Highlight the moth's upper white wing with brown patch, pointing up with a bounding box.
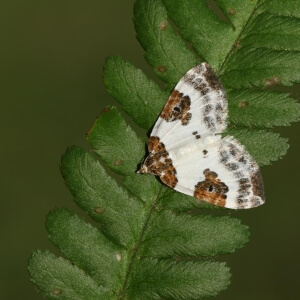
[151,63,228,150]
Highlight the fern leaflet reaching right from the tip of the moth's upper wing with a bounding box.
[221,46,300,89]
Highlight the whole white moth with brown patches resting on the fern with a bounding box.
[138,63,265,209]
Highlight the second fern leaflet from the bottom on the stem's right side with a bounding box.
[140,211,249,258]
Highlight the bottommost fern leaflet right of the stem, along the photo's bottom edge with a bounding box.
[125,259,230,300]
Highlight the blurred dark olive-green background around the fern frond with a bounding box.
[0,0,300,300]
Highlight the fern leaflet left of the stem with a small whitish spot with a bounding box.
[46,209,127,289]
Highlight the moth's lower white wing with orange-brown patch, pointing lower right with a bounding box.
[161,135,265,209]
